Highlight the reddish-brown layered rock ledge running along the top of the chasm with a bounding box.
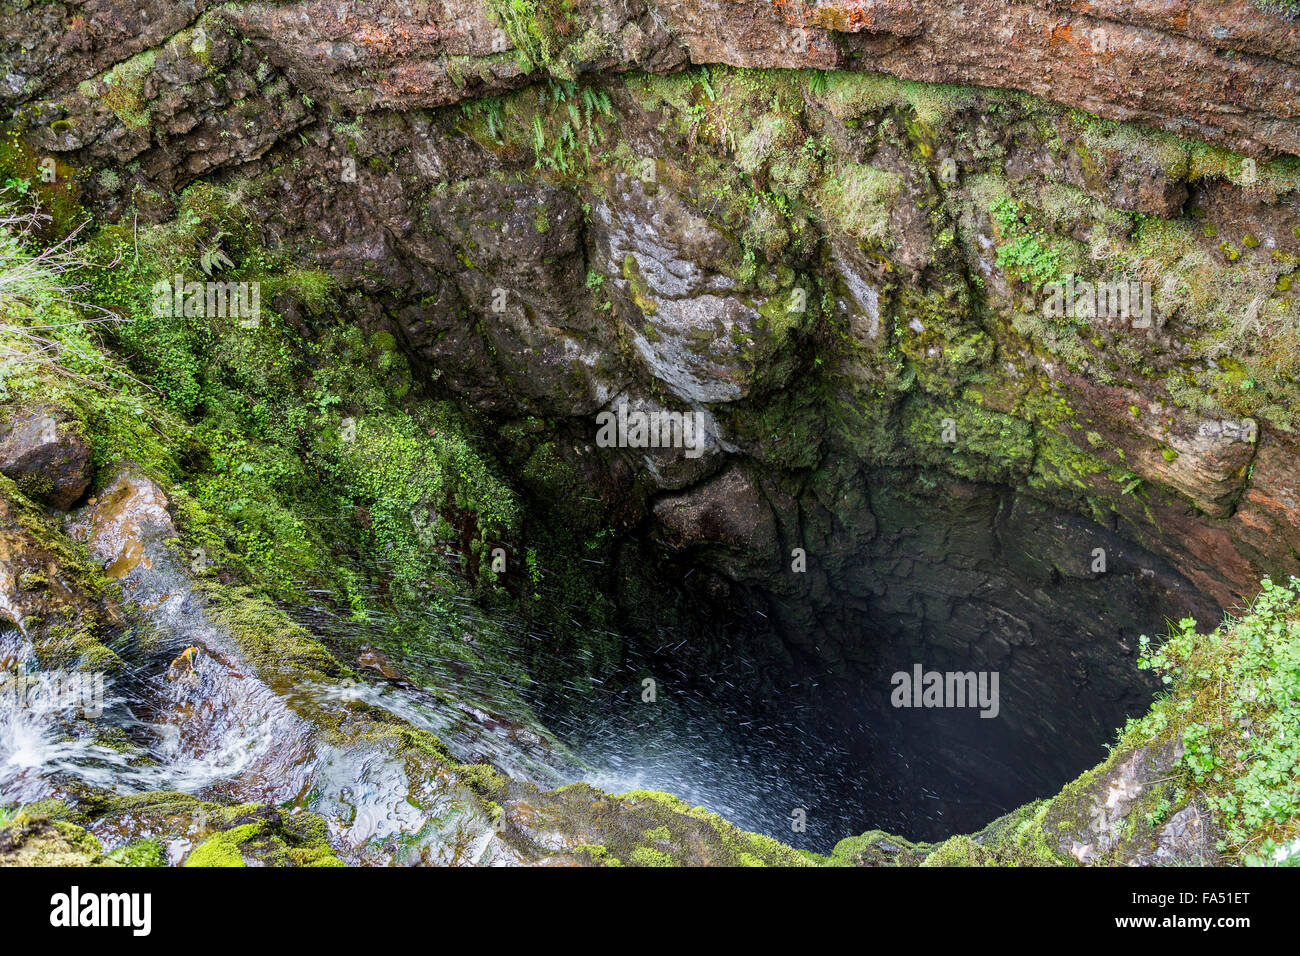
[4,0,1300,153]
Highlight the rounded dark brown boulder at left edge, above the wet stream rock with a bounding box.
[0,407,95,509]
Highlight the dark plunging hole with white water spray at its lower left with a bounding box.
[527,485,1221,853]
